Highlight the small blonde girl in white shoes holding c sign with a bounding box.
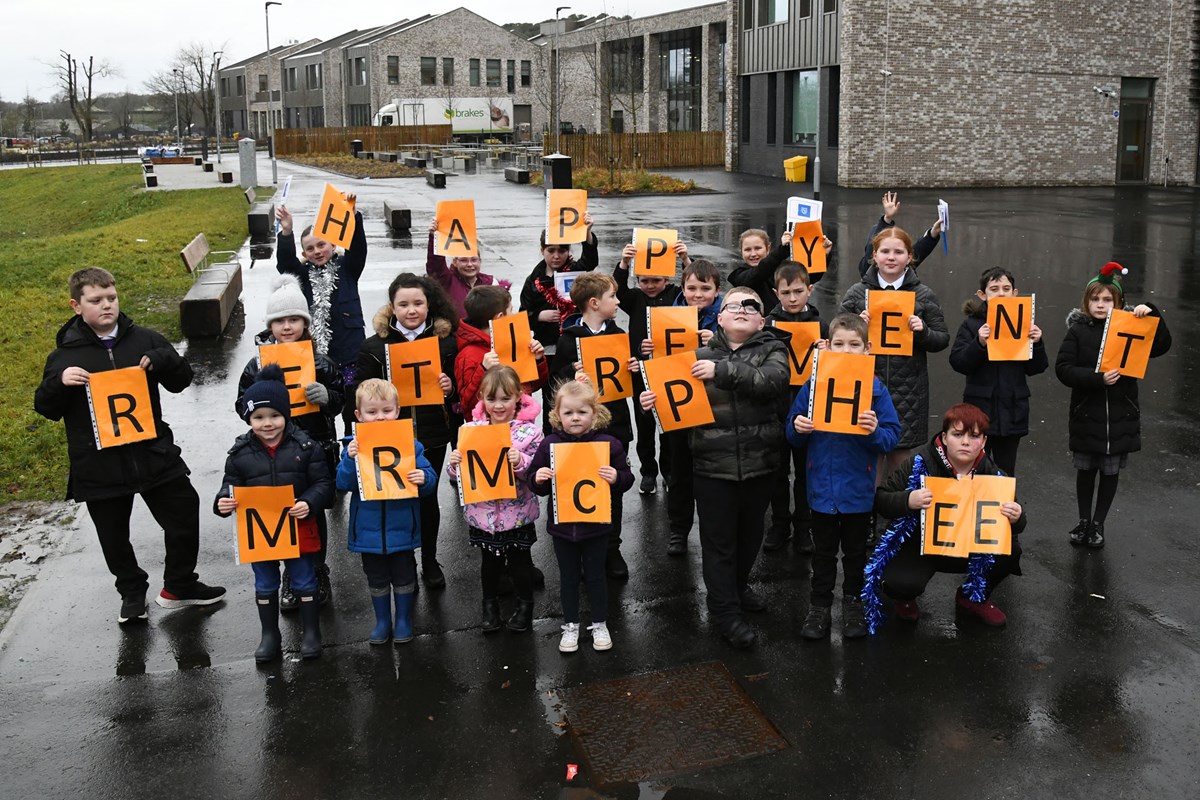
[529,380,634,652]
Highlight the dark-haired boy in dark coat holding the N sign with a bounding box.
[950,266,1050,476]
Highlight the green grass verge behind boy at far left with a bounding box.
[0,164,270,504]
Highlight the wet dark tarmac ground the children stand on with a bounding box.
[0,154,1200,800]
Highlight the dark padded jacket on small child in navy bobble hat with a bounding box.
[212,421,334,517]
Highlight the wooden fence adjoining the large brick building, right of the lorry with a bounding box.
[542,131,725,169]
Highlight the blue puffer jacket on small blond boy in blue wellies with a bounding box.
[337,441,438,555]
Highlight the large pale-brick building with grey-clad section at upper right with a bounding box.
[726,0,1200,187]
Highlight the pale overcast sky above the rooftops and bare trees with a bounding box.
[0,0,706,102]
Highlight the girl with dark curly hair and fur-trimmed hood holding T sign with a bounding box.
[354,272,458,589]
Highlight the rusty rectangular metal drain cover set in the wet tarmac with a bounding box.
[558,661,787,786]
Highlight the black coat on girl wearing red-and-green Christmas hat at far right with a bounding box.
[1055,306,1171,455]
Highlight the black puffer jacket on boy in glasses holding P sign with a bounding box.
[689,327,790,481]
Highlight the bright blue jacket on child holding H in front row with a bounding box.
[786,378,900,513]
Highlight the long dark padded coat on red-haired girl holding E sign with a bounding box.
[841,265,950,450]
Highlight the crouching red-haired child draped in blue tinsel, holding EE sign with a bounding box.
[863,403,1026,633]
